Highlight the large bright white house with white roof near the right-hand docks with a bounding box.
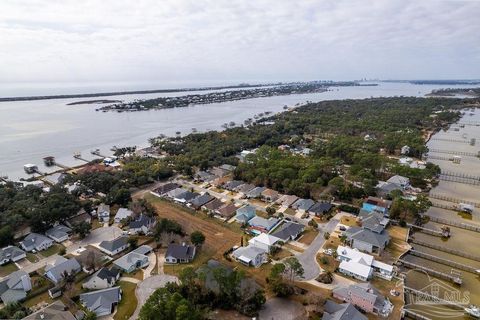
[337,246,393,281]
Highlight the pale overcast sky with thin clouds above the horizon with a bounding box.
[0,0,480,85]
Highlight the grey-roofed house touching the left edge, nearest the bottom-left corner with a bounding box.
[0,270,32,305]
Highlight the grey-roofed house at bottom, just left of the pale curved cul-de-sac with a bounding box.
[80,287,122,317]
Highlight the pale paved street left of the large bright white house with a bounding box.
[297,217,340,280]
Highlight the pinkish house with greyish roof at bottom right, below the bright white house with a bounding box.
[332,283,393,318]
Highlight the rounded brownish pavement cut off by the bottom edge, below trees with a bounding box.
[258,298,307,320]
